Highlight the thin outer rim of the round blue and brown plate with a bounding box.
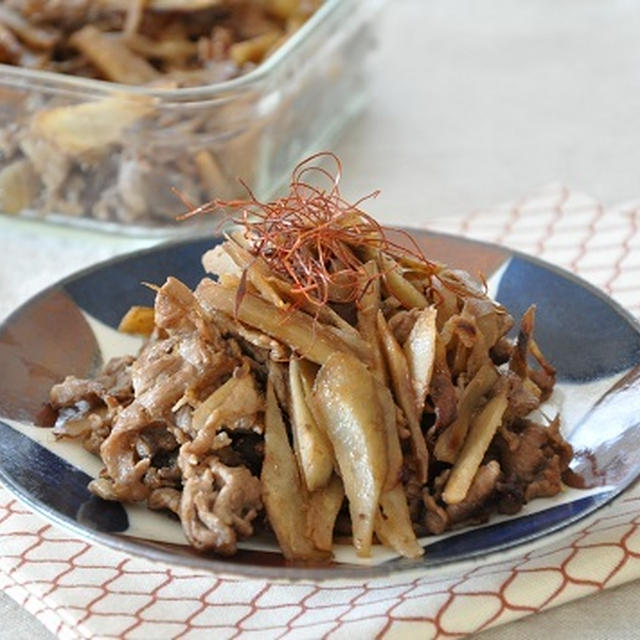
[0,227,640,583]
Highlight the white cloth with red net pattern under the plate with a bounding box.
[0,186,640,640]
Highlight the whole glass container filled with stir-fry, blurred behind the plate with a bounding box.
[0,0,381,229]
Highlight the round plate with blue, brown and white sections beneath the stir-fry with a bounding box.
[0,231,640,580]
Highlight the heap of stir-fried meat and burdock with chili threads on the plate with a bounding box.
[50,154,572,561]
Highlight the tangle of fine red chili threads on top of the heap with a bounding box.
[178,152,473,307]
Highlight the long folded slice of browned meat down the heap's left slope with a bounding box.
[92,278,241,501]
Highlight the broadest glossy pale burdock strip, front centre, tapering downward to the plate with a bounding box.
[313,352,388,557]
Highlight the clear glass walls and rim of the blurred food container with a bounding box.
[0,0,381,235]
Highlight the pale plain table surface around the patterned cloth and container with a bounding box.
[0,0,640,640]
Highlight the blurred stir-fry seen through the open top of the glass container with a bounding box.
[0,0,321,87]
